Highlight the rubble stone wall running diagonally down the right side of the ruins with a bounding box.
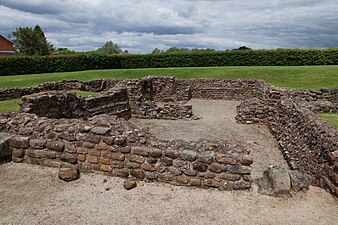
[236,89,338,196]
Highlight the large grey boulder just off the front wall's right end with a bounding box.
[257,166,291,197]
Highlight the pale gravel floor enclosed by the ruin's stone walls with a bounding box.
[132,99,288,179]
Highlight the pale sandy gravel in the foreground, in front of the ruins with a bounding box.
[0,163,338,225]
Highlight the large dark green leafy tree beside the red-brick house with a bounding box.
[10,25,54,55]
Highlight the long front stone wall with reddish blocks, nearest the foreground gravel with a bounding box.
[0,114,253,189]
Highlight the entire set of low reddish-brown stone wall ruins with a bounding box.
[0,76,338,196]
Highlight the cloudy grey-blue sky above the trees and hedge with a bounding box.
[0,0,338,53]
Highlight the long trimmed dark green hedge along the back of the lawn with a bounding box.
[0,49,338,76]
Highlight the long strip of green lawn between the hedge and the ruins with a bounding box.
[0,66,338,89]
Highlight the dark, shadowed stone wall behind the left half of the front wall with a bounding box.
[20,89,131,118]
